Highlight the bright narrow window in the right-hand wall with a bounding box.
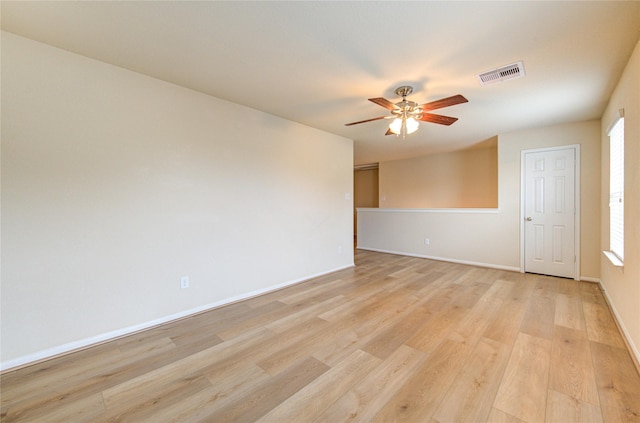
[609,113,624,266]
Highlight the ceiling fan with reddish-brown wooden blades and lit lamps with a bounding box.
[345,85,469,138]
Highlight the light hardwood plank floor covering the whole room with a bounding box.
[0,250,640,423]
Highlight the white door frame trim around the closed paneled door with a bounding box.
[520,144,580,281]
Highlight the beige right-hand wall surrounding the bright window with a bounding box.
[599,42,640,361]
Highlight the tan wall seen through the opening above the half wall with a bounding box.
[380,142,498,208]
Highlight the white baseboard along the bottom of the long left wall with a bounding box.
[0,263,355,372]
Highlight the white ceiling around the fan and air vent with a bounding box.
[1,1,640,164]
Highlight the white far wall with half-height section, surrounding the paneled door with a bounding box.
[358,121,600,280]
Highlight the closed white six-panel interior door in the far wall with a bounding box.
[523,147,577,279]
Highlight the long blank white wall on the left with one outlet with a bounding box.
[1,32,353,368]
